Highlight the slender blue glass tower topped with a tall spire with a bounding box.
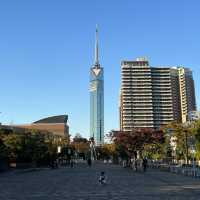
[90,29,104,146]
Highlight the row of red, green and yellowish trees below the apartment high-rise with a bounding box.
[109,121,200,163]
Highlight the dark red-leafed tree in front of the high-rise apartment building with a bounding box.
[110,128,164,157]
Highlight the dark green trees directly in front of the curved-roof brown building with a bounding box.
[0,129,68,165]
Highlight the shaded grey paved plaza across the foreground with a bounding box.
[0,164,200,200]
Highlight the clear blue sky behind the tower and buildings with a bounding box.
[0,0,200,136]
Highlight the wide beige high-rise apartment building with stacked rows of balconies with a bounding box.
[120,58,196,131]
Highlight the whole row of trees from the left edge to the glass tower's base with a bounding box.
[0,129,91,170]
